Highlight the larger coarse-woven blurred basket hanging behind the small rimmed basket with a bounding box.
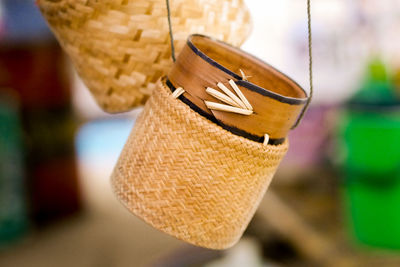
[38,0,251,113]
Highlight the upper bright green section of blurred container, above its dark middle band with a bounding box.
[342,110,400,173]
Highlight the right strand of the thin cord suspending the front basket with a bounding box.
[292,0,314,129]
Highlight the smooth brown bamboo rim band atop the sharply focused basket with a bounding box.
[167,34,308,143]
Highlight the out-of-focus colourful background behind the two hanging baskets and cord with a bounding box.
[0,0,400,267]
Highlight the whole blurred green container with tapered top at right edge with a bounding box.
[340,60,400,249]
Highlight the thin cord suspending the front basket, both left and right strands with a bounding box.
[166,0,314,129]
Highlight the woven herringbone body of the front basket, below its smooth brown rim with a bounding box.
[111,79,288,249]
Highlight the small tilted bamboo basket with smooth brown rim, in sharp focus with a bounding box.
[111,35,307,249]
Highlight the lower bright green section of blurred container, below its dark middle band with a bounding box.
[344,172,400,249]
